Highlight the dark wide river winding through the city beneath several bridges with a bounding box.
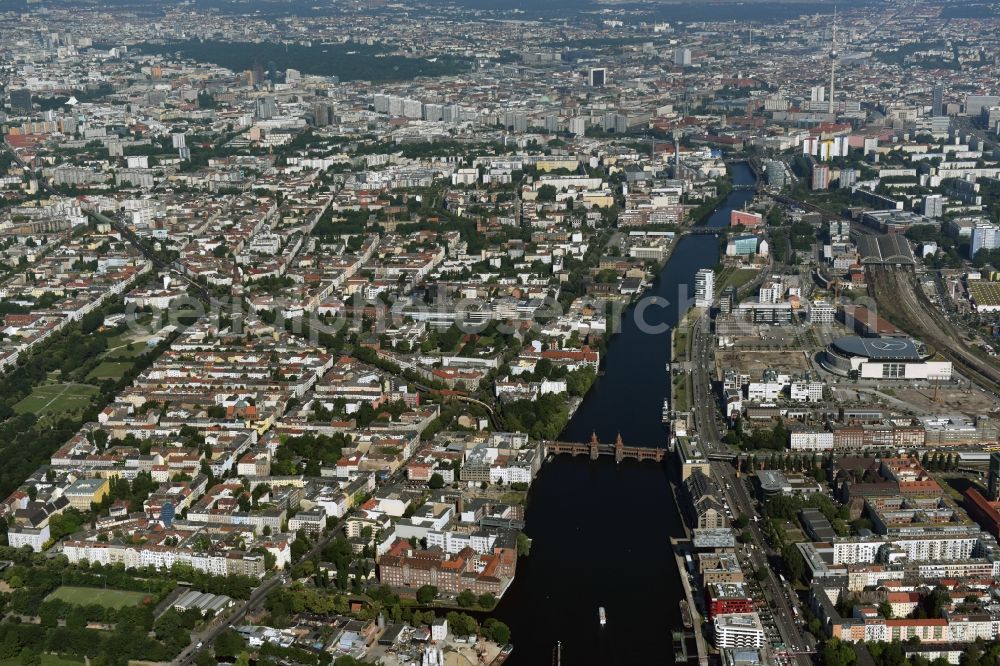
[496,164,754,666]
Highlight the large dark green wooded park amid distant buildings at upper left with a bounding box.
[131,39,470,83]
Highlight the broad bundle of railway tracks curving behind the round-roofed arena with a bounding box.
[868,265,1000,394]
